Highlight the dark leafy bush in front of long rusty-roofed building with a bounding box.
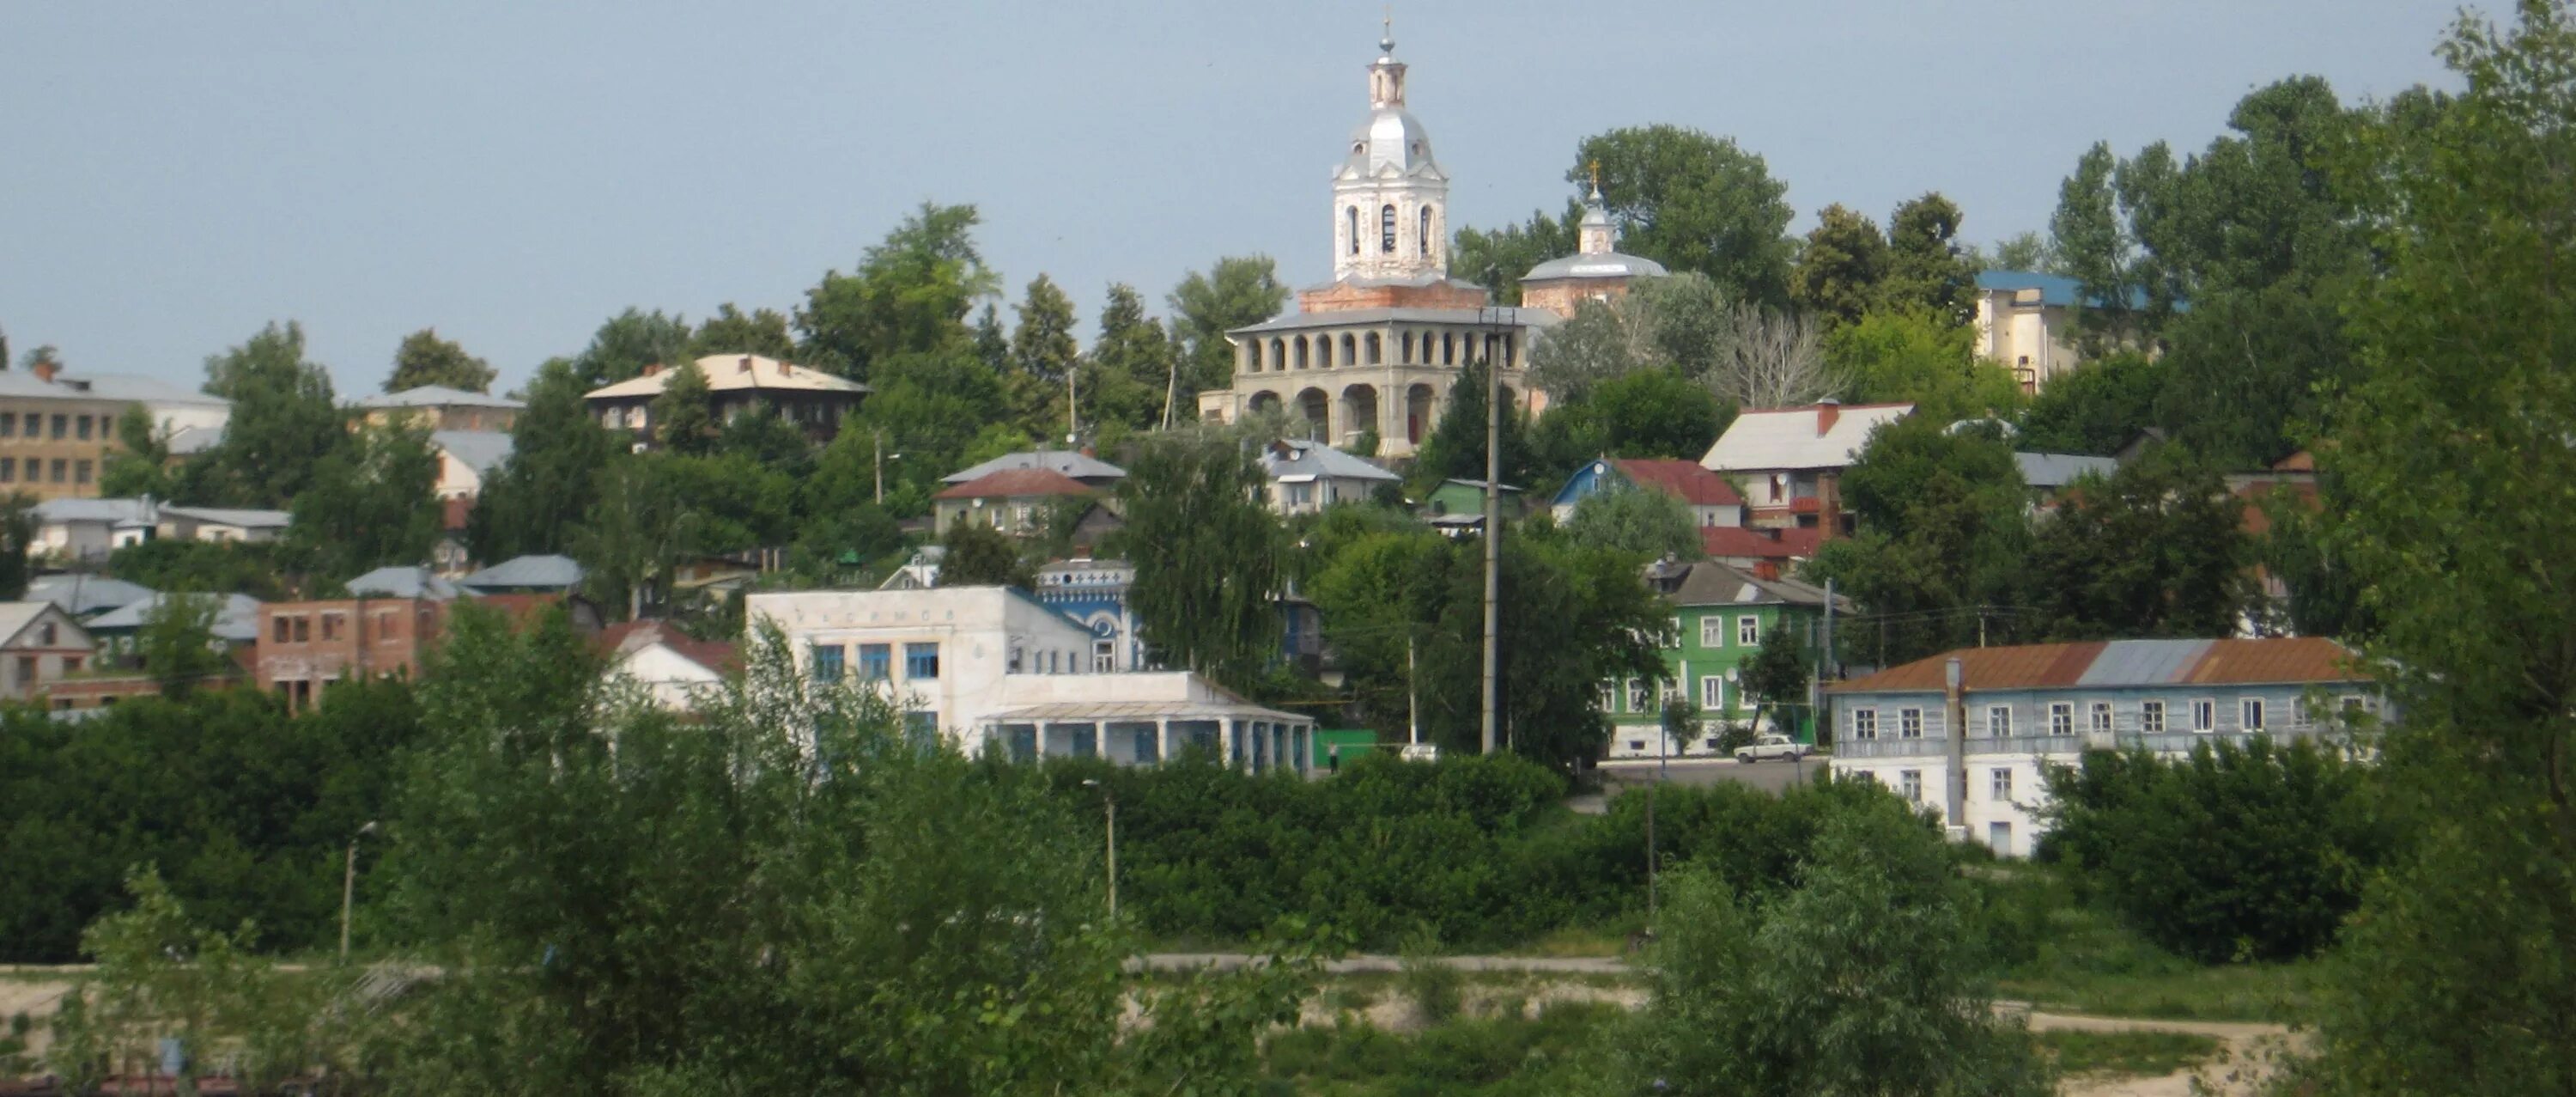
[2048,739,2393,963]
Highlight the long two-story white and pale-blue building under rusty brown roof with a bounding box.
[1826,636,2378,855]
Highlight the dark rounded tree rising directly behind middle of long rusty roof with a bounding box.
[2030,446,2251,638]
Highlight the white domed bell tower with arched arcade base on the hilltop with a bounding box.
[1198,36,1556,456]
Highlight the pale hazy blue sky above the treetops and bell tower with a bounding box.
[0,0,2455,397]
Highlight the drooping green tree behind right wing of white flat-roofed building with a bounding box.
[1115,433,1280,687]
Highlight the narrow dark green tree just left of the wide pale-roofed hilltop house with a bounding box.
[466,358,621,561]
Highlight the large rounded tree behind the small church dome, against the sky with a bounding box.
[1566,126,1793,307]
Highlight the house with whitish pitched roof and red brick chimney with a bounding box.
[1700,399,1914,539]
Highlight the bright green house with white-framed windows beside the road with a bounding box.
[1600,558,1850,757]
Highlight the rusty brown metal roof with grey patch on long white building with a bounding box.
[1829,636,2365,692]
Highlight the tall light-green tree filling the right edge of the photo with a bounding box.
[2318,3,2576,1094]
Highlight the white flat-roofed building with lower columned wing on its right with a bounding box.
[747,587,1314,772]
